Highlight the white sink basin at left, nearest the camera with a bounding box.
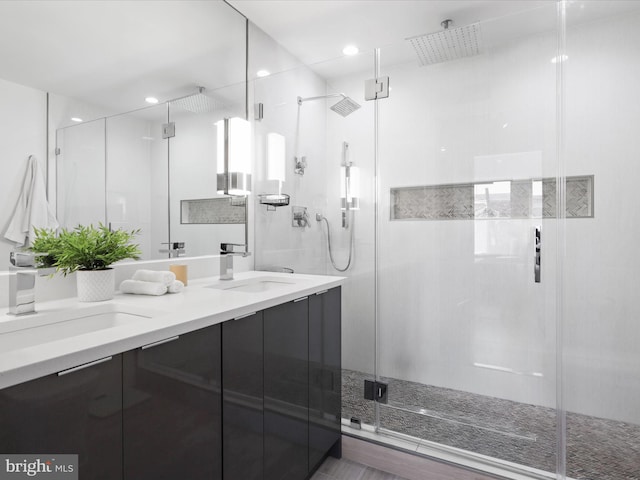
[0,304,152,353]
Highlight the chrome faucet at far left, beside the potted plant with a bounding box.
[8,252,56,315]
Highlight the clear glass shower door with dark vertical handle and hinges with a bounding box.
[377,2,558,473]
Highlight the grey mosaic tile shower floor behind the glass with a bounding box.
[342,370,640,480]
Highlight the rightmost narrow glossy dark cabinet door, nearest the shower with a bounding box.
[309,287,342,470]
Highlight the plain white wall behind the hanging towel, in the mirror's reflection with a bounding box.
[0,79,47,271]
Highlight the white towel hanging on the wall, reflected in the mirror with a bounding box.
[4,155,58,247]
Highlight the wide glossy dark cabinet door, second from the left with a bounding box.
[123,325,222,480]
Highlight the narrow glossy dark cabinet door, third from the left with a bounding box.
[222,312,264,480]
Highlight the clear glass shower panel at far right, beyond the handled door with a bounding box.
[562,1,640,480]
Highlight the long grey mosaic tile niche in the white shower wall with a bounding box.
[391,175,594,220]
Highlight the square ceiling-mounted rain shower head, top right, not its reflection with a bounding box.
[405,20,480,67]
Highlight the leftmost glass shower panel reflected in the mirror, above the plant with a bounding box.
[56,119,106,228]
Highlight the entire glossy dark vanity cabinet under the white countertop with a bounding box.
[0,287,341,480]
